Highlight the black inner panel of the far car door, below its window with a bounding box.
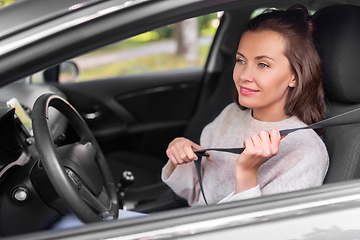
[57,68,203,157]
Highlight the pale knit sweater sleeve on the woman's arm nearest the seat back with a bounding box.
[219,130,329,203]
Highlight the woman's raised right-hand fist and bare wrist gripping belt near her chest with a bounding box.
[235,130,281,193]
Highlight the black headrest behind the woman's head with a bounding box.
[313,5,360,103]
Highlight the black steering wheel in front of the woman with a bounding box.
[31,94,119,223]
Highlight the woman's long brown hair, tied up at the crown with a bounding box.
[234,5,326,135]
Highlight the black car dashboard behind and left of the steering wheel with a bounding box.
[0,80,68,236]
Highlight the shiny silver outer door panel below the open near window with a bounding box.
[4,181,360,240]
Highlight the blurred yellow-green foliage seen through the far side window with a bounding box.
[73,13,221,81]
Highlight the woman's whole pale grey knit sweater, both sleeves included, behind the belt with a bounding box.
[162,103,329,206]
